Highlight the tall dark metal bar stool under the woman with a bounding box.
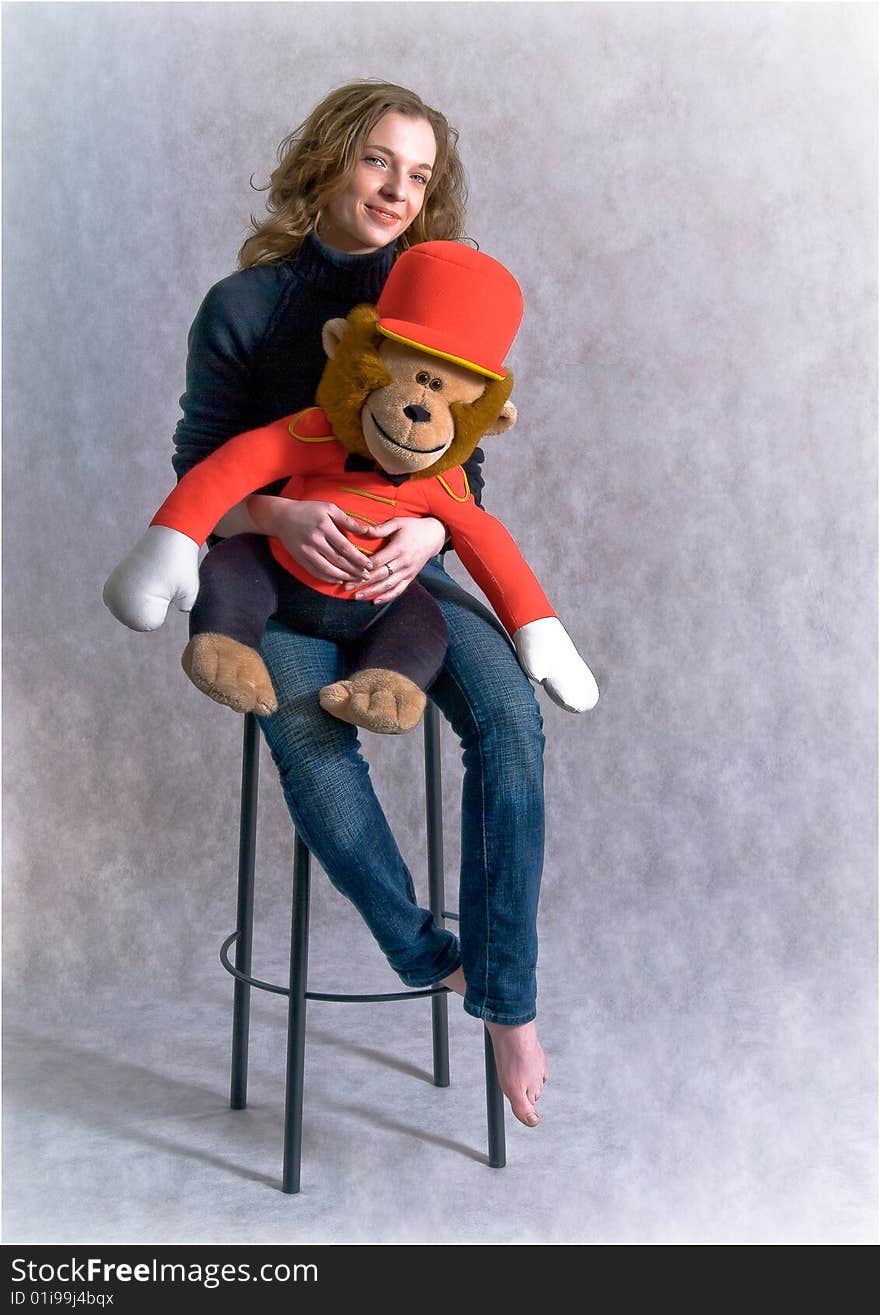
[220,702,505,1193]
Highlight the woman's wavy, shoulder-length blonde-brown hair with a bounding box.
[232,79,467,270]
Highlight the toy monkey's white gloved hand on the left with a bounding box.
[104,525,199,630]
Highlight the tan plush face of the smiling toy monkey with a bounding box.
[360,339,487,475]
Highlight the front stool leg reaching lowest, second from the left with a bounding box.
[281,835,309,1194]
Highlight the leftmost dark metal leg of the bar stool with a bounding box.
[229,713,259,1110]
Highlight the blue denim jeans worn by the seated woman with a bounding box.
[253,558,545,1024]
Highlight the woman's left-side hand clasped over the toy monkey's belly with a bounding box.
[247,493,373,588]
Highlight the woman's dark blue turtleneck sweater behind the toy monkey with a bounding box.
[172,234,483,502]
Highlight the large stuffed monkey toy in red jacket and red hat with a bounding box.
[104,242,599,734]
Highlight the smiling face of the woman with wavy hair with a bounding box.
[318,110,437,255]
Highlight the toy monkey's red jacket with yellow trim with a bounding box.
[151,406,556,635]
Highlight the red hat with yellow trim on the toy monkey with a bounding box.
[376,242,522,379]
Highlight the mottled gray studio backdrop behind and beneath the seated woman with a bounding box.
[3,3,877,1243]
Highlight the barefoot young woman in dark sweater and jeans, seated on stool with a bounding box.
[174,82,547,1127]
